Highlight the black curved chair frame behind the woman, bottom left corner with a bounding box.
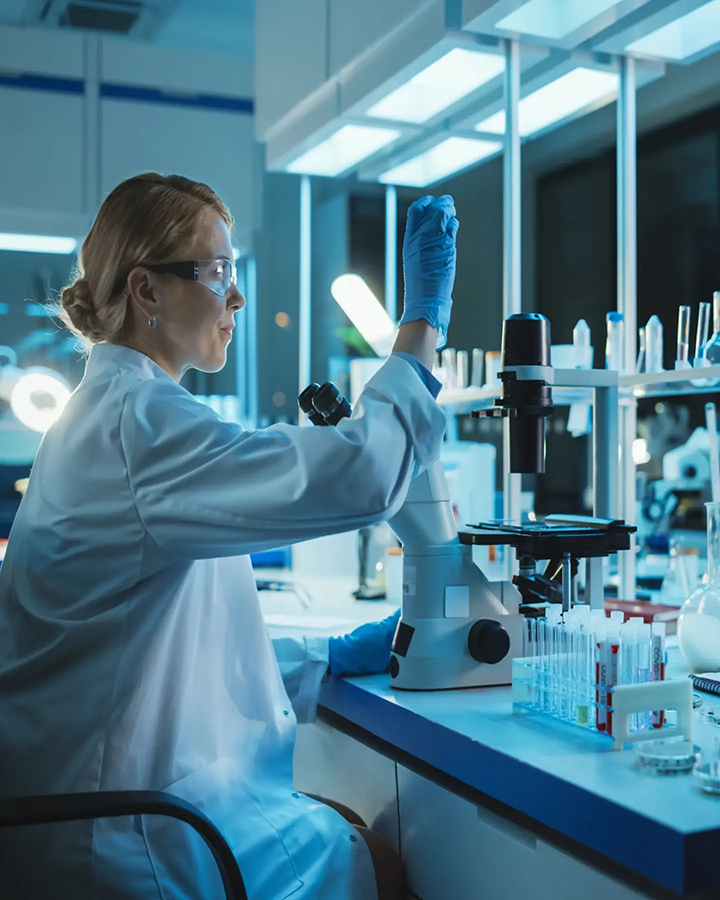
[0,791,247,900]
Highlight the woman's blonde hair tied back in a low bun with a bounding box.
[60,172,232,344]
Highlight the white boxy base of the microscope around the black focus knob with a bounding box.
[390,615,524,691]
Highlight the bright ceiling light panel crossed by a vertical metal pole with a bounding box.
[475,68,617,137]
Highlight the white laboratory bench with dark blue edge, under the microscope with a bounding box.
[262,579,720,900]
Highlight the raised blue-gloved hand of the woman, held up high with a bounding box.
[400,194,459,350]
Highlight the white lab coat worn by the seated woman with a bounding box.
[0,345,444,900]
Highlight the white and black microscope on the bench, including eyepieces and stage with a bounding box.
[299,313,634,691]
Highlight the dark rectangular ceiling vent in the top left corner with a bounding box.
[25,0,178,39]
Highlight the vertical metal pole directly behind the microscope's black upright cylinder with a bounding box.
[503,41,522,536]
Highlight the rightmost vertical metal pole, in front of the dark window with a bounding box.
[617,57,637,600]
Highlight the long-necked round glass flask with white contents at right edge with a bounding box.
[678,503,720,672]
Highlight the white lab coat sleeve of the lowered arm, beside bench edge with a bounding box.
[272,637,330,725]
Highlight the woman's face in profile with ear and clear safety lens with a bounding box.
[133,213,245,378]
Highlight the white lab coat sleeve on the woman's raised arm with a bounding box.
[120,356,445,559]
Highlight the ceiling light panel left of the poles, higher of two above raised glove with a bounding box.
[367,47,505,124]
